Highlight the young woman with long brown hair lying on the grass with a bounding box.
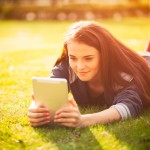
[28,21,150,127]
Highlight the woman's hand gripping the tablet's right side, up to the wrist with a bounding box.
[54,99,81,127]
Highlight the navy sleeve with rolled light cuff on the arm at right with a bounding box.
[111,85,143,120]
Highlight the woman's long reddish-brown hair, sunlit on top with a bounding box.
[55,21,150,105]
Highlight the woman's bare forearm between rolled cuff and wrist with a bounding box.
[81,108,121,127]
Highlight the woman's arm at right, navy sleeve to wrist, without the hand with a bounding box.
[83,85,143,124]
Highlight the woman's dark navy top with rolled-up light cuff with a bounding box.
[50,53,150,118]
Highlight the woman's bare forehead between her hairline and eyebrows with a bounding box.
[67,41,99,56]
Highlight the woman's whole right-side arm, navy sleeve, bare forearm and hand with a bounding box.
[54,86,143,127]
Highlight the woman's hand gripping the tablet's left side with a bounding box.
[28,95,50,127]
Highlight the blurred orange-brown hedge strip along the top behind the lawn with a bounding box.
[0,0,150,20]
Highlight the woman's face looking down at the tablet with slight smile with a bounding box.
[67,41,100,81]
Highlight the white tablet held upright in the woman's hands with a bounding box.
[32,77,68,116]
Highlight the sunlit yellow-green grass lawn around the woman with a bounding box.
[0,18,150,150]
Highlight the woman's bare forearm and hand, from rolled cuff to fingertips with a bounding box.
[54,99,121,127]
